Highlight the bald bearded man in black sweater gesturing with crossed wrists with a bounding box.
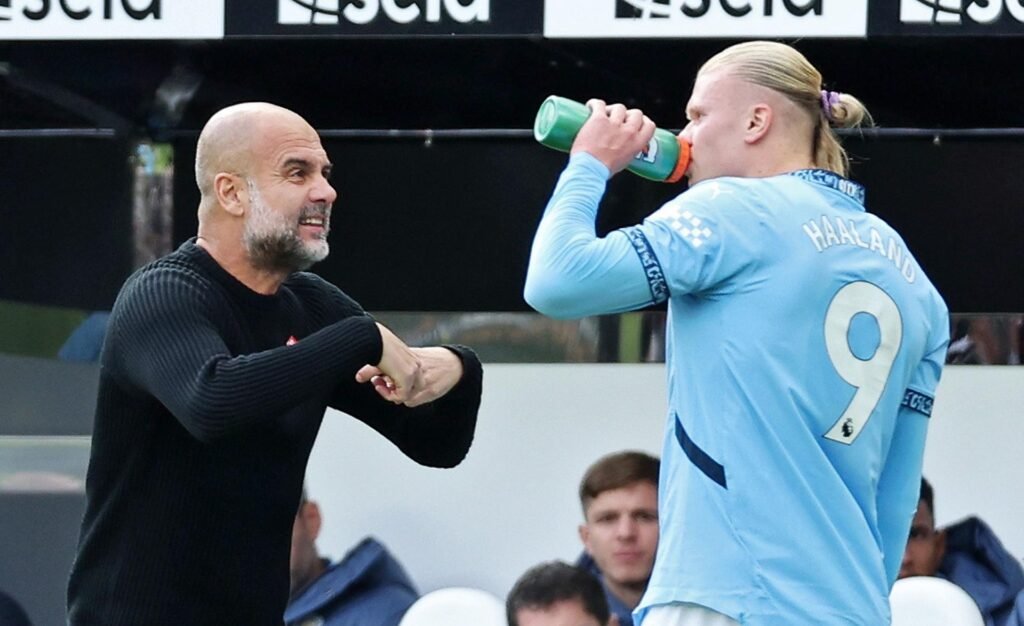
[68,102,482,626]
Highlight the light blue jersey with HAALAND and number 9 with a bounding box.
[525,154,948,626]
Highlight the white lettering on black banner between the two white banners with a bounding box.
[278,0,490,25]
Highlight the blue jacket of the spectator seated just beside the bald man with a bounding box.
[285,537,419,626]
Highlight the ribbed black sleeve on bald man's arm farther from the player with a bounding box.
[103,267,382,442]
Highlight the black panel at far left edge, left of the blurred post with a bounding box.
[0,138,132,309]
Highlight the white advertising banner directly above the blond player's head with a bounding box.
[544,0,867,39]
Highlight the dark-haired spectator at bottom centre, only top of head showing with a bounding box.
[505,560,617,626]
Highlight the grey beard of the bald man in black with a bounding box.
[242,179,330,273]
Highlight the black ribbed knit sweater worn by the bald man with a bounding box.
[68,241,482,626]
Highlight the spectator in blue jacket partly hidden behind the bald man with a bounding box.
[285,493,419,626]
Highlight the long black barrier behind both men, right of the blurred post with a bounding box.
[163,131,1024,312]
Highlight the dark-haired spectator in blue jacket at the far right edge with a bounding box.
[899,478,1024,626]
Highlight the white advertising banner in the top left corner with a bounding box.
[0,0,224,41]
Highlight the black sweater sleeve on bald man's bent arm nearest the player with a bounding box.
[331,345,483,467]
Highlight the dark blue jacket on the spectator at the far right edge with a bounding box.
[938,517,1024,626]
